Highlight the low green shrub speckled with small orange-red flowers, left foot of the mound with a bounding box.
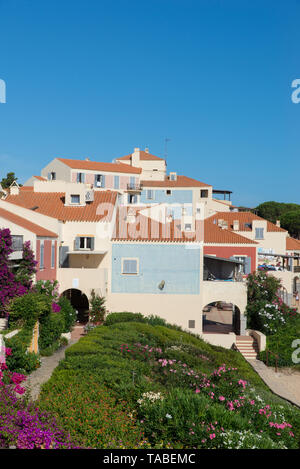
[39,370,148,449]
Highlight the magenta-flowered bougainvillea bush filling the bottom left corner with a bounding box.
[0,348,78,449]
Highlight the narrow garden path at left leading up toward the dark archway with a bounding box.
[25,325,84,401]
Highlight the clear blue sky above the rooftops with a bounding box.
[0,0,300,206]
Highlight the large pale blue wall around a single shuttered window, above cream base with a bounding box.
[111,243,200,295]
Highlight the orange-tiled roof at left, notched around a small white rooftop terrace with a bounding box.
[5,191,117,222]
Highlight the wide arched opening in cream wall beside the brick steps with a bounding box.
[202,301,241,335]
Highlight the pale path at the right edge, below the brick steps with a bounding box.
[247,360,300,407]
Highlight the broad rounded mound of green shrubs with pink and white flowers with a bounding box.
[39,320,300,449]
